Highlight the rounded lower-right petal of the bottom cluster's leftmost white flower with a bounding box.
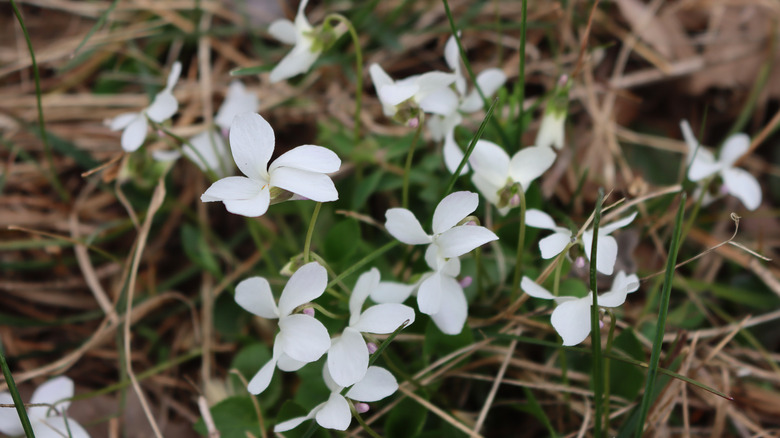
[276,314,330,362]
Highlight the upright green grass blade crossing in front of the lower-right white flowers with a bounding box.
[586,189,604,438]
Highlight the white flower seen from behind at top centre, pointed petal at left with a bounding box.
[368,64,458,123]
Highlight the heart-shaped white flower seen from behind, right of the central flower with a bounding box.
[469,140,555,215]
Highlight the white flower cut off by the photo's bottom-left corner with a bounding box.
[0,376,89,438]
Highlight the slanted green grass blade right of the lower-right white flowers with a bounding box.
[635,193,686,438]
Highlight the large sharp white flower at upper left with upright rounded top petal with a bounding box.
[200,113,341,216]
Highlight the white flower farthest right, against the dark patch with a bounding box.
[680,120,761,210]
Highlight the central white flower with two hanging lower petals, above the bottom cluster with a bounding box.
[386,192,498,334]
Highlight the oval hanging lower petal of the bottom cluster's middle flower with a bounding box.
[328,327,368,387]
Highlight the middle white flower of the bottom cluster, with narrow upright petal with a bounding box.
[328,268,414,387]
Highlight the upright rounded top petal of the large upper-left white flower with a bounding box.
[230,113,276,181]
